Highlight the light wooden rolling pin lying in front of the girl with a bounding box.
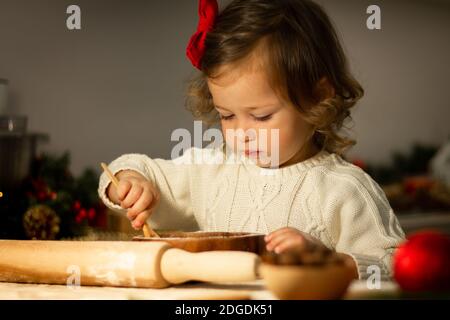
[0,240,260,288]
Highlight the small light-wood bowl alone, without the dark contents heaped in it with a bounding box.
[260,263,353,300]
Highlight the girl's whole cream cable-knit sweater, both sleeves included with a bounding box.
[98,144,404,280]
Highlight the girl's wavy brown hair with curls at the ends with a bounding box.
[186,0,364,154]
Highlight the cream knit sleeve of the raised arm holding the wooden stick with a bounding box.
[98,150,198,231]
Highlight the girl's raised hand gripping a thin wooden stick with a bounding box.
[107,170,160,230]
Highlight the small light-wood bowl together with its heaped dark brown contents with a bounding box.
[260,249,354,300]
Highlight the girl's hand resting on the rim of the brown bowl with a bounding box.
[264,228,326,253]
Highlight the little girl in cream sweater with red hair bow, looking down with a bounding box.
[99,0,404,279]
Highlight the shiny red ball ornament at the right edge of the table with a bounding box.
[394,231,450,292]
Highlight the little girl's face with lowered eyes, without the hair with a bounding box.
[208,62,317,167]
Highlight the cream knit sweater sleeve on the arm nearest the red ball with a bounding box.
[314,169,405,280]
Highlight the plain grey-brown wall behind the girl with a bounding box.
[0,0,450,174]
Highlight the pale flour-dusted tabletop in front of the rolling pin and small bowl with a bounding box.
[0,280,397,300]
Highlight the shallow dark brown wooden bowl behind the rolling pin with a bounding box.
[133,231,265,254]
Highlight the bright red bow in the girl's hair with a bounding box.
[186,0,219,70]
